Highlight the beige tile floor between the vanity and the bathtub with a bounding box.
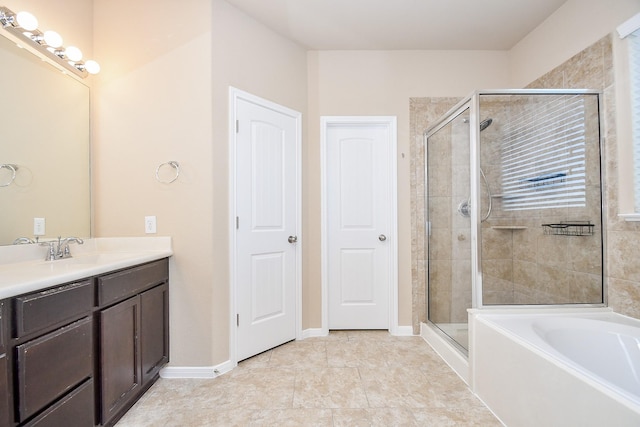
[117,331,501,427]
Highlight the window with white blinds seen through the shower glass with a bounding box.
[501,95,586,210]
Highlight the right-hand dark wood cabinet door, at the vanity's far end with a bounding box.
[140,283,169,384]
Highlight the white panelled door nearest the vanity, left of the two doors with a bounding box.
[234,92,300,360]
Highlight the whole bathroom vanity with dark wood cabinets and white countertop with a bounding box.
[0,239,171,427]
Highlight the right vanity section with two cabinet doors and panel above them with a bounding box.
[98,260,169,425]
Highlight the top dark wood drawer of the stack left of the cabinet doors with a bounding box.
[15,280,94,337]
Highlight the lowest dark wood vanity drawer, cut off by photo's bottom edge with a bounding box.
[25,379,95,427]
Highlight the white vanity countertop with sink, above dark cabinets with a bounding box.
[0,237,173,299]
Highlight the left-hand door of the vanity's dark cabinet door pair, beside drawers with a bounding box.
[100,296,142,424]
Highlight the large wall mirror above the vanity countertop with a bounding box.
[0,31,91,245]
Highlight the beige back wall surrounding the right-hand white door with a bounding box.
[303,51,509,328]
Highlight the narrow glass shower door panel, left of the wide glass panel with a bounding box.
[425,107,471,353]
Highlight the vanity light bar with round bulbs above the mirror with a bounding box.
[0,6,100,79]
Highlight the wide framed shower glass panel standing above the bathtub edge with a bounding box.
[479,93,604,305]
